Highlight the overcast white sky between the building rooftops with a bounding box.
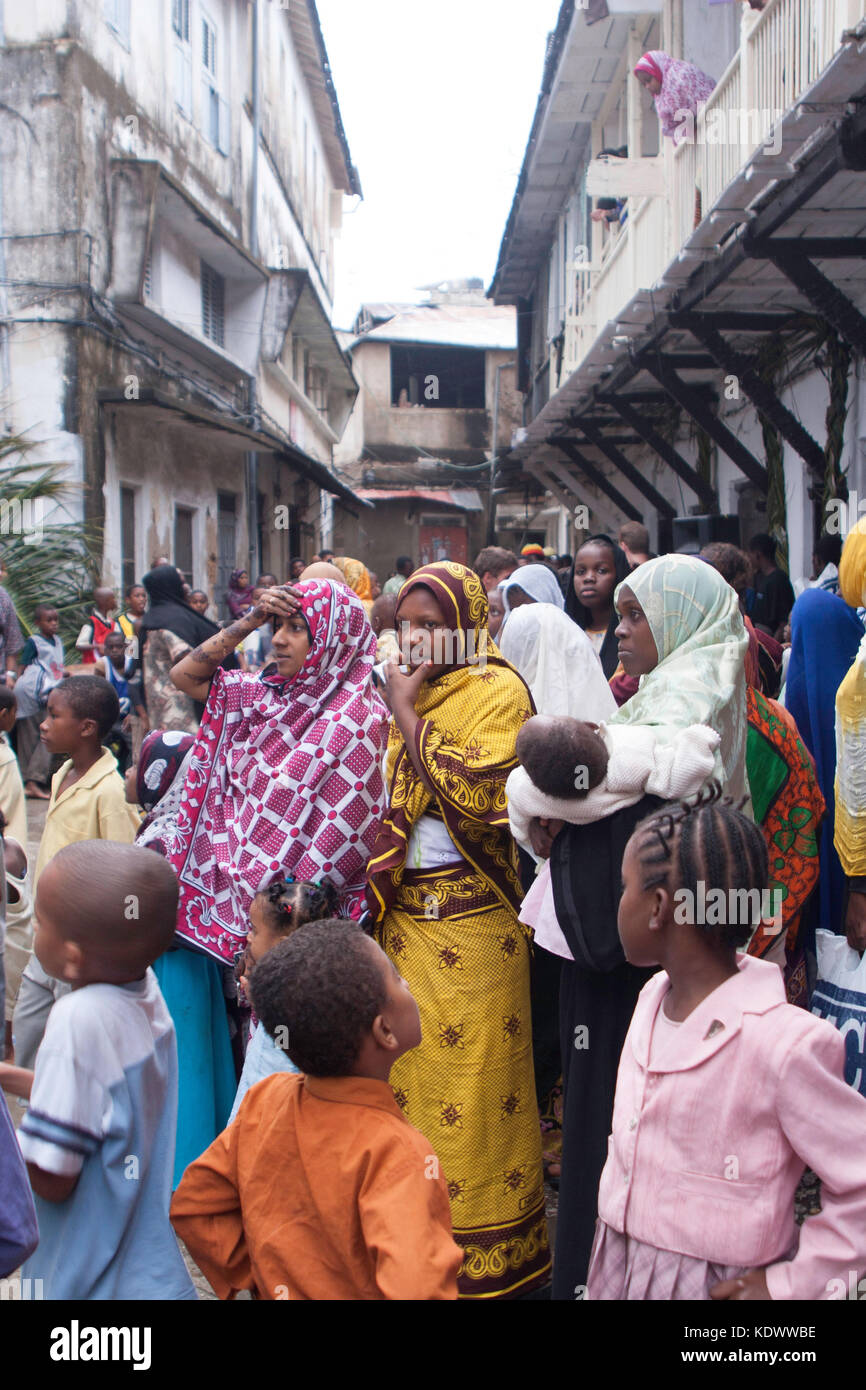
[317,0,560,328]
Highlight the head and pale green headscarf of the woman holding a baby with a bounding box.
[610,555,749,802]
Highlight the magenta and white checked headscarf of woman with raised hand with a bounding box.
[167,580,388,962]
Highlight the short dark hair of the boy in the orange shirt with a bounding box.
[249,917,385,1076]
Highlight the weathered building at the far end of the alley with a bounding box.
[336,282,520,577]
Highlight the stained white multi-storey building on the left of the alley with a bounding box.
[0,0,360,612]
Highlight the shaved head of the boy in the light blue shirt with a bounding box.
[33,840,178,988]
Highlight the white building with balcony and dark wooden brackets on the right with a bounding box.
[489,0,866,578]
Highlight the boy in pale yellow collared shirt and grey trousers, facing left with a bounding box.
[13,676,139,1068]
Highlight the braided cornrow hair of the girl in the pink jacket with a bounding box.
[632,781,769,949]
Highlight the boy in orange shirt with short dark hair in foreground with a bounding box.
[171,919,463,1300]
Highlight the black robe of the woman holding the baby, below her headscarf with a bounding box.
[550,796,660,1300]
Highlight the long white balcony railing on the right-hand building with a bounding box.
[550,0,866,389]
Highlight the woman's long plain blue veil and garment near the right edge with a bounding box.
[785,589,863,955]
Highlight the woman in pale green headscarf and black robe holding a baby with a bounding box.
[542,555,749,1300]
